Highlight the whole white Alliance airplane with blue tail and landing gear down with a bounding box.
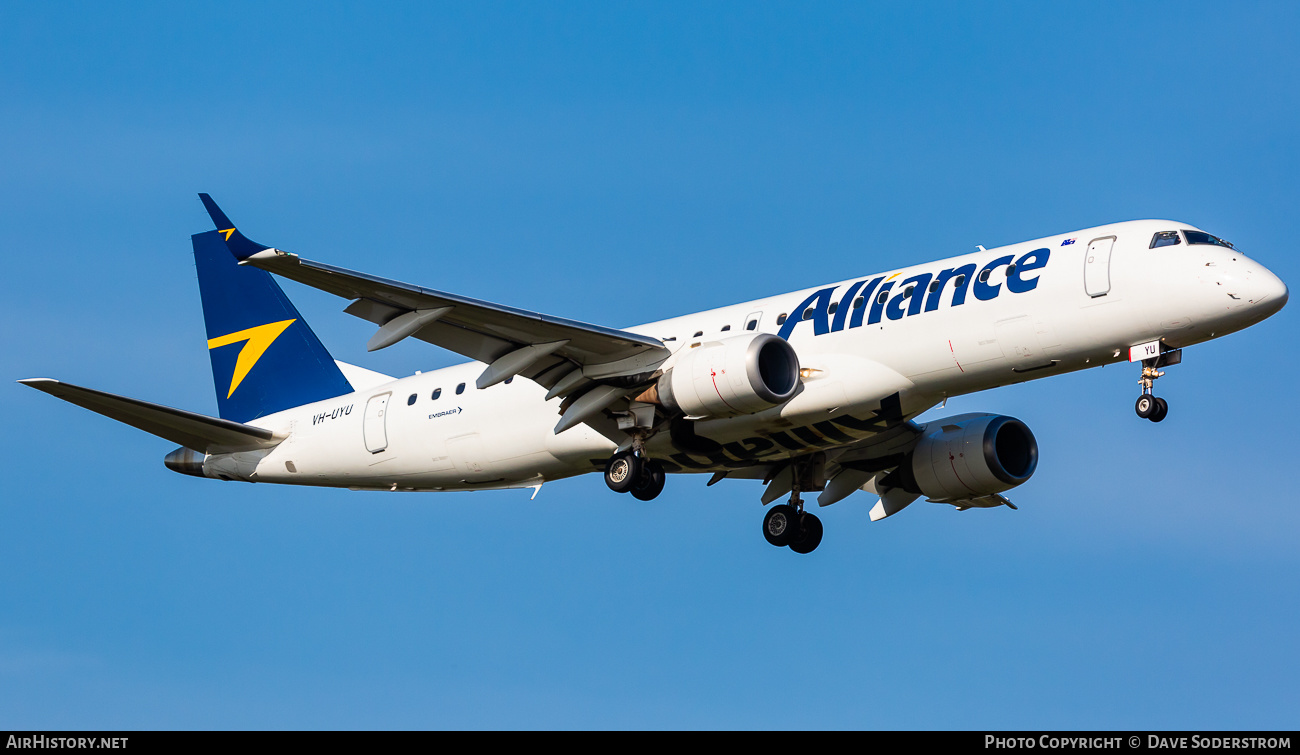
[18,194,1288,554]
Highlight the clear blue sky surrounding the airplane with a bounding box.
[0,3,1300,729]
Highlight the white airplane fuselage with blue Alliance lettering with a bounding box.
[204,221,1287,490]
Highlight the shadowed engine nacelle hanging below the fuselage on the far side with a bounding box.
[905,415,1039,500]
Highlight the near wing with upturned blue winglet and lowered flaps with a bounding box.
[199,194,670,398]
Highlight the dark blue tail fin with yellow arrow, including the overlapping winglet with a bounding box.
[191,195,352,422]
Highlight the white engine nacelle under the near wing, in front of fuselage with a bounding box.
[655,333,800,417]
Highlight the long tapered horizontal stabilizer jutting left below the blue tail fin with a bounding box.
[18,378,283,452]
